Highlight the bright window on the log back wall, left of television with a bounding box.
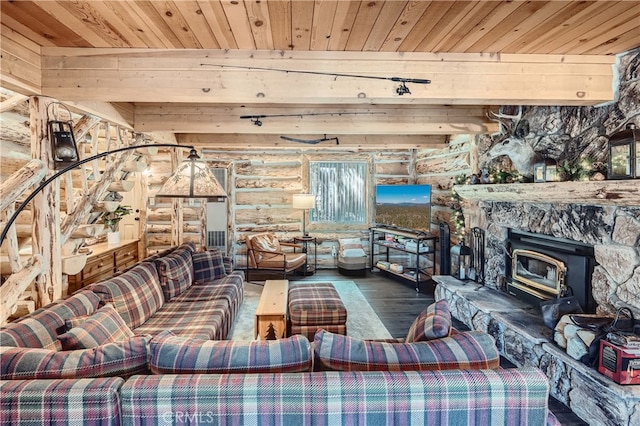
[309,161,367,224]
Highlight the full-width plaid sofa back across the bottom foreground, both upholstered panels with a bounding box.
[0,368,558,426]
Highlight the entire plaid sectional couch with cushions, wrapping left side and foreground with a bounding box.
[0,246,556,426]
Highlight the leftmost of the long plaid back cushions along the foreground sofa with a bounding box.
[0,336,151,380]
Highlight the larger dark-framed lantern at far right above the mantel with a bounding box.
[607,123,640,179]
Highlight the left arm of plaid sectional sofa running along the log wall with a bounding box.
[0,244,244,424]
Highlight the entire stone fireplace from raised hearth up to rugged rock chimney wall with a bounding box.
[434,50,640,426]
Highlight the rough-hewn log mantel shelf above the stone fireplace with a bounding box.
[454,179,640,206]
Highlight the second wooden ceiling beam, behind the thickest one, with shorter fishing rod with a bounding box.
[135,104,498,135]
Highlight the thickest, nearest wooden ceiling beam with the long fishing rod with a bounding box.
[42,48,615,105]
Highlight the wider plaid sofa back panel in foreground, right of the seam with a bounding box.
[120,368,549,426]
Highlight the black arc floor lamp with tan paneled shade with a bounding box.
[0,144,227,245]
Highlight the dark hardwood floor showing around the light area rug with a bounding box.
[292,269,588,426]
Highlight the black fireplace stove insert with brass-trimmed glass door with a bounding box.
[506,229,596,312]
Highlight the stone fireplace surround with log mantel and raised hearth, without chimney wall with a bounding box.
[444,189,640,426]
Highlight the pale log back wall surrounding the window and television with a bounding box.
[152,141,472,268]
